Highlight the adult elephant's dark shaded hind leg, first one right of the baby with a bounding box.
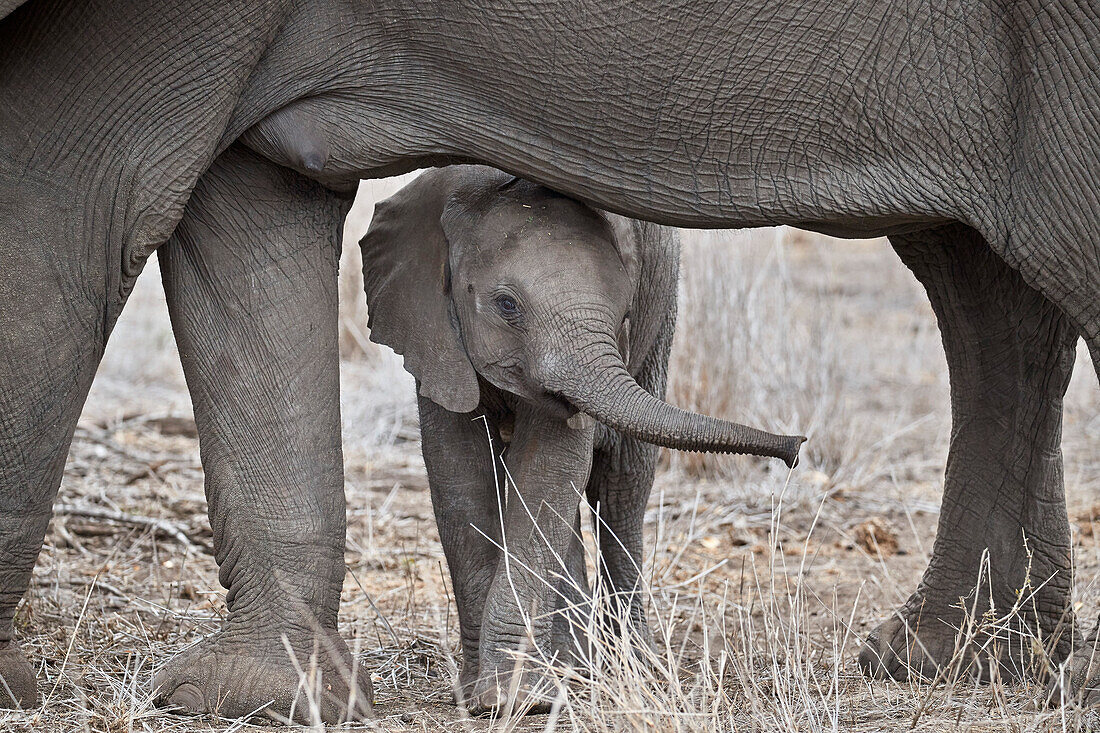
[859,227,1077,679]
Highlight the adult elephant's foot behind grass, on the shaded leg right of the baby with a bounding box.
[859,597,1034,681]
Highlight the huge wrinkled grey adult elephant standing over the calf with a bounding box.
[0,0,1100,719]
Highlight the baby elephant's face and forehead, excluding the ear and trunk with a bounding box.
[441,169,634,417]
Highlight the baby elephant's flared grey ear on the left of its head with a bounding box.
[359,168,481,413]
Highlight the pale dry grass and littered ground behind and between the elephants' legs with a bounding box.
[0,182,1100,733]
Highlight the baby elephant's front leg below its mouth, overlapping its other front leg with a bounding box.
[471,406,593,711]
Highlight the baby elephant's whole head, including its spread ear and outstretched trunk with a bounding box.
[360,166,802,466]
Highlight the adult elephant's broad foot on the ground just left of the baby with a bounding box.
[153,632,372,724]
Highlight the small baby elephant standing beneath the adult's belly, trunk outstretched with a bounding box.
[360,166,803,711]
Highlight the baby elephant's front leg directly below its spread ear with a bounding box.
[418,396,504,700]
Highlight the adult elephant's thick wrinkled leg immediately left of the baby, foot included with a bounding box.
[154,147,370,721]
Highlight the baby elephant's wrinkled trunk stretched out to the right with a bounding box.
[548,338,805,467]
